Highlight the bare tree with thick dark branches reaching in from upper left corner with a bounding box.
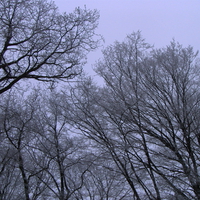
[0,0,100,93]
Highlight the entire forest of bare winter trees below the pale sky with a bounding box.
[0,0,200,200]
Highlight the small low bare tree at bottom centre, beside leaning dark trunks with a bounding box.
[81,151,132,200]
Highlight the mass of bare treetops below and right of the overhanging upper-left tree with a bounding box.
[0,32,200,200]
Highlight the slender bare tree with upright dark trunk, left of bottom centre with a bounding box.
[35,92,90,200]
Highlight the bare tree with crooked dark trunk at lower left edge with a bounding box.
[0,90,46,200]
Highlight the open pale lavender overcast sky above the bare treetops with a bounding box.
[54,0,200,77]
